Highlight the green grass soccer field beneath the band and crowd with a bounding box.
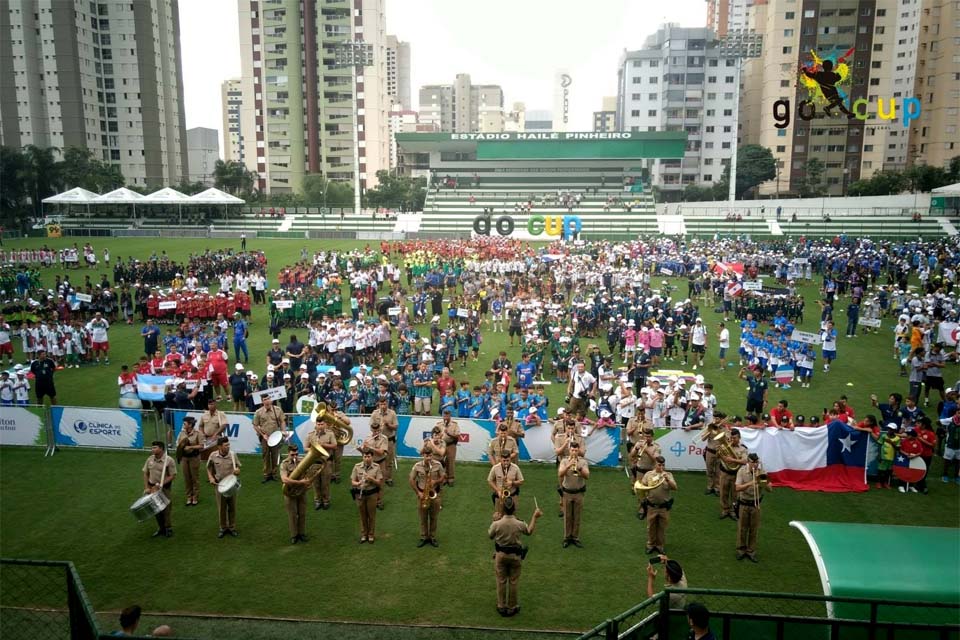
[0,238,960,630]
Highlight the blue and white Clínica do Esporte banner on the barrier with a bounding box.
[50,406,143,449]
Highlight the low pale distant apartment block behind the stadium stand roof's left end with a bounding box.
[420,73,504,133]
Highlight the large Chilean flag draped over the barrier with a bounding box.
[740,420,870,493]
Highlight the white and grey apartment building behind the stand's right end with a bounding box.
[616,24,737,200]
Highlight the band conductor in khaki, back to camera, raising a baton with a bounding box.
[487,498,543,617]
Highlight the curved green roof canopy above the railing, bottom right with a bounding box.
[790,520,960,623]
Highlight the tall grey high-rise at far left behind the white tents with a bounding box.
[0,0,187,188]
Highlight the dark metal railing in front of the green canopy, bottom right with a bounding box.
[580,589,960,640]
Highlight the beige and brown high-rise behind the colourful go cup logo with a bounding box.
[740,0,932,195]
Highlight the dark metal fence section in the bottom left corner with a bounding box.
[0,558,181,640]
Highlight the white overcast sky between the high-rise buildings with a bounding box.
[180,0,707,146]
